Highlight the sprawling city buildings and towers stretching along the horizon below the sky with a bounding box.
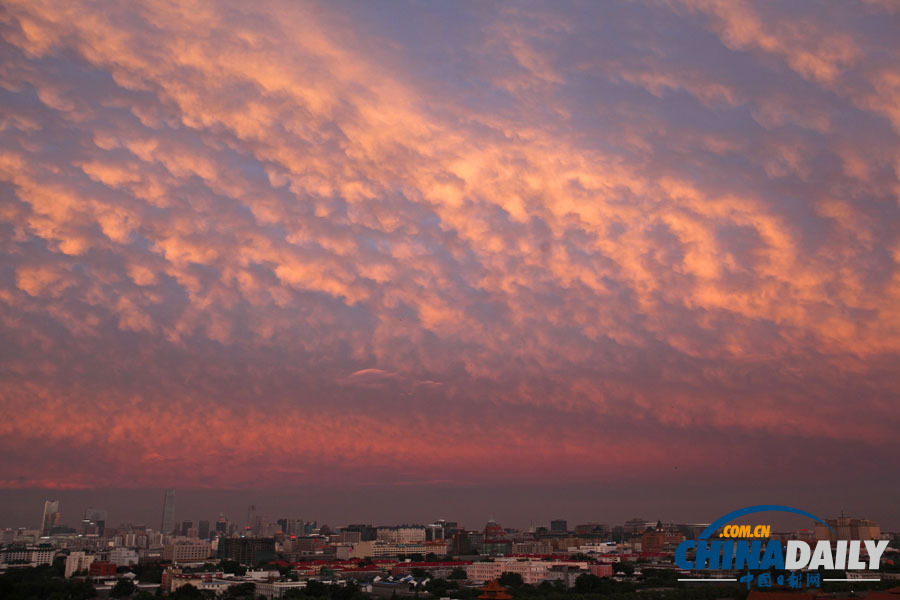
[0,489,897,598]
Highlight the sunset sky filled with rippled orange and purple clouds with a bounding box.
[0,0,900,527]
